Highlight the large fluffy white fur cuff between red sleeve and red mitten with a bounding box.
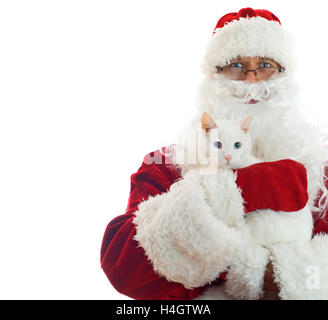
[133,169,245,289]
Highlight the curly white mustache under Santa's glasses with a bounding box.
[215,74,288,103]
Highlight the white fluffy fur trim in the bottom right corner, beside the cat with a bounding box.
[271,235,328,300]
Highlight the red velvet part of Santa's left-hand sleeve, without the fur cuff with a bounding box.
[101,153,210,300]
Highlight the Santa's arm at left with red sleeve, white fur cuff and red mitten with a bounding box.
[101,148,306,299]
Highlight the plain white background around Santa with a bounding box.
[0,0,328,299]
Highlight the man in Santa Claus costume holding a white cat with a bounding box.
[101,8,328,299]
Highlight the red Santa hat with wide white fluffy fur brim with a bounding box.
[203,8,294,76]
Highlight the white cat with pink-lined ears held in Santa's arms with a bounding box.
[195,113,313,299]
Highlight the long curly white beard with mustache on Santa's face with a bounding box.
[184,76,328,211]
